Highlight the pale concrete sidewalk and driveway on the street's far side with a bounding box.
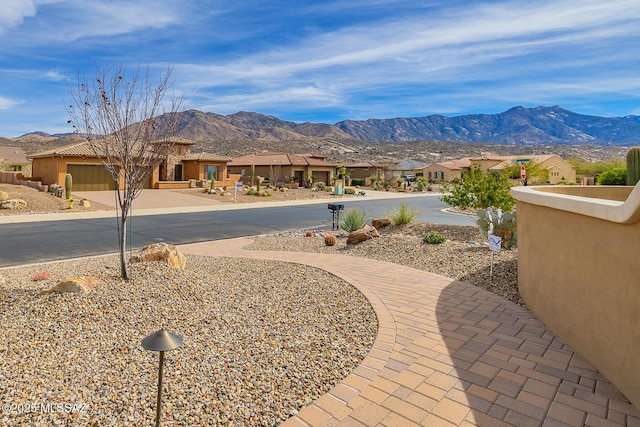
[0,190,440,224]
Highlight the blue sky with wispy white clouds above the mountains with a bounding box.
[0,0,640,137]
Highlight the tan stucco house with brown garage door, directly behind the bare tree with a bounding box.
[29,139,235,191]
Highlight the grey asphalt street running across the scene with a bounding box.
[0,197,474,267]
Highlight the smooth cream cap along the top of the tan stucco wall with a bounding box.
[511,183,640,224]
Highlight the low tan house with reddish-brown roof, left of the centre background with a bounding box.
[227,152,336,185]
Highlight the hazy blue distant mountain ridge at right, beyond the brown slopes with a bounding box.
[336,106,640,145]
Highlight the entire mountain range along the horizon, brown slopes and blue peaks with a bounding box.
[0,106,640,160]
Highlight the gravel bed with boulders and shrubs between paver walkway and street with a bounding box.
[247,223,525,307]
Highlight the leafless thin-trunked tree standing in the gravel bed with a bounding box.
[67,66,182,280]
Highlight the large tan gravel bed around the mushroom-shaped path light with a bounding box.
[0,256,377,426]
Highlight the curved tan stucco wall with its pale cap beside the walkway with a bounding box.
[512,187,640,407]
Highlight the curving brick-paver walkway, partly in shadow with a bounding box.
[180,239,640,427]
